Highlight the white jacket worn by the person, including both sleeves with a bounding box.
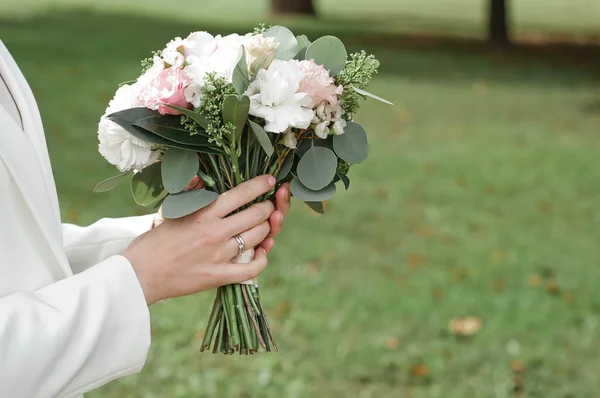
[0,41,152,398]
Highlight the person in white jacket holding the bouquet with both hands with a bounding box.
[0,41,290,398]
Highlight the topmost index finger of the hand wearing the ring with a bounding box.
[211,175,276,217]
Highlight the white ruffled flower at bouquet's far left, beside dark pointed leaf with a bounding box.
[98,83,159,172]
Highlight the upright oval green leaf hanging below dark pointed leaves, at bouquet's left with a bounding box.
[161,148,200,193]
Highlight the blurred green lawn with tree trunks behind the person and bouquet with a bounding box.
[0,0,600,398]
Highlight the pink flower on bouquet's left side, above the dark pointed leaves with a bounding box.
[138,68,190,115]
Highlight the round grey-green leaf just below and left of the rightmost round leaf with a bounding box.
[296,146,337,191]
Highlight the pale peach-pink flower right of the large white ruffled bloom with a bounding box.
[298,59,344,109]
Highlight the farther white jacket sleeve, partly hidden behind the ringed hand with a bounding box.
[63,214,155,274]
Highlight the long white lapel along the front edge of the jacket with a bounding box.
[0,41,72,275]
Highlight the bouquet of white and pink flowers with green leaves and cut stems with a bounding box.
[95,26,389,354]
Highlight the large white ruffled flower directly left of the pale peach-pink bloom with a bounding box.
[246,60,314,133]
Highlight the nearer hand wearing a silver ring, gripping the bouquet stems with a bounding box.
[123,176,278,305]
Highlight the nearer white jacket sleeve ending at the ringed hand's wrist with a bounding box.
[0,256,150,398]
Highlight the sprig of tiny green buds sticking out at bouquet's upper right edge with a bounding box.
[335,50,379,120]
